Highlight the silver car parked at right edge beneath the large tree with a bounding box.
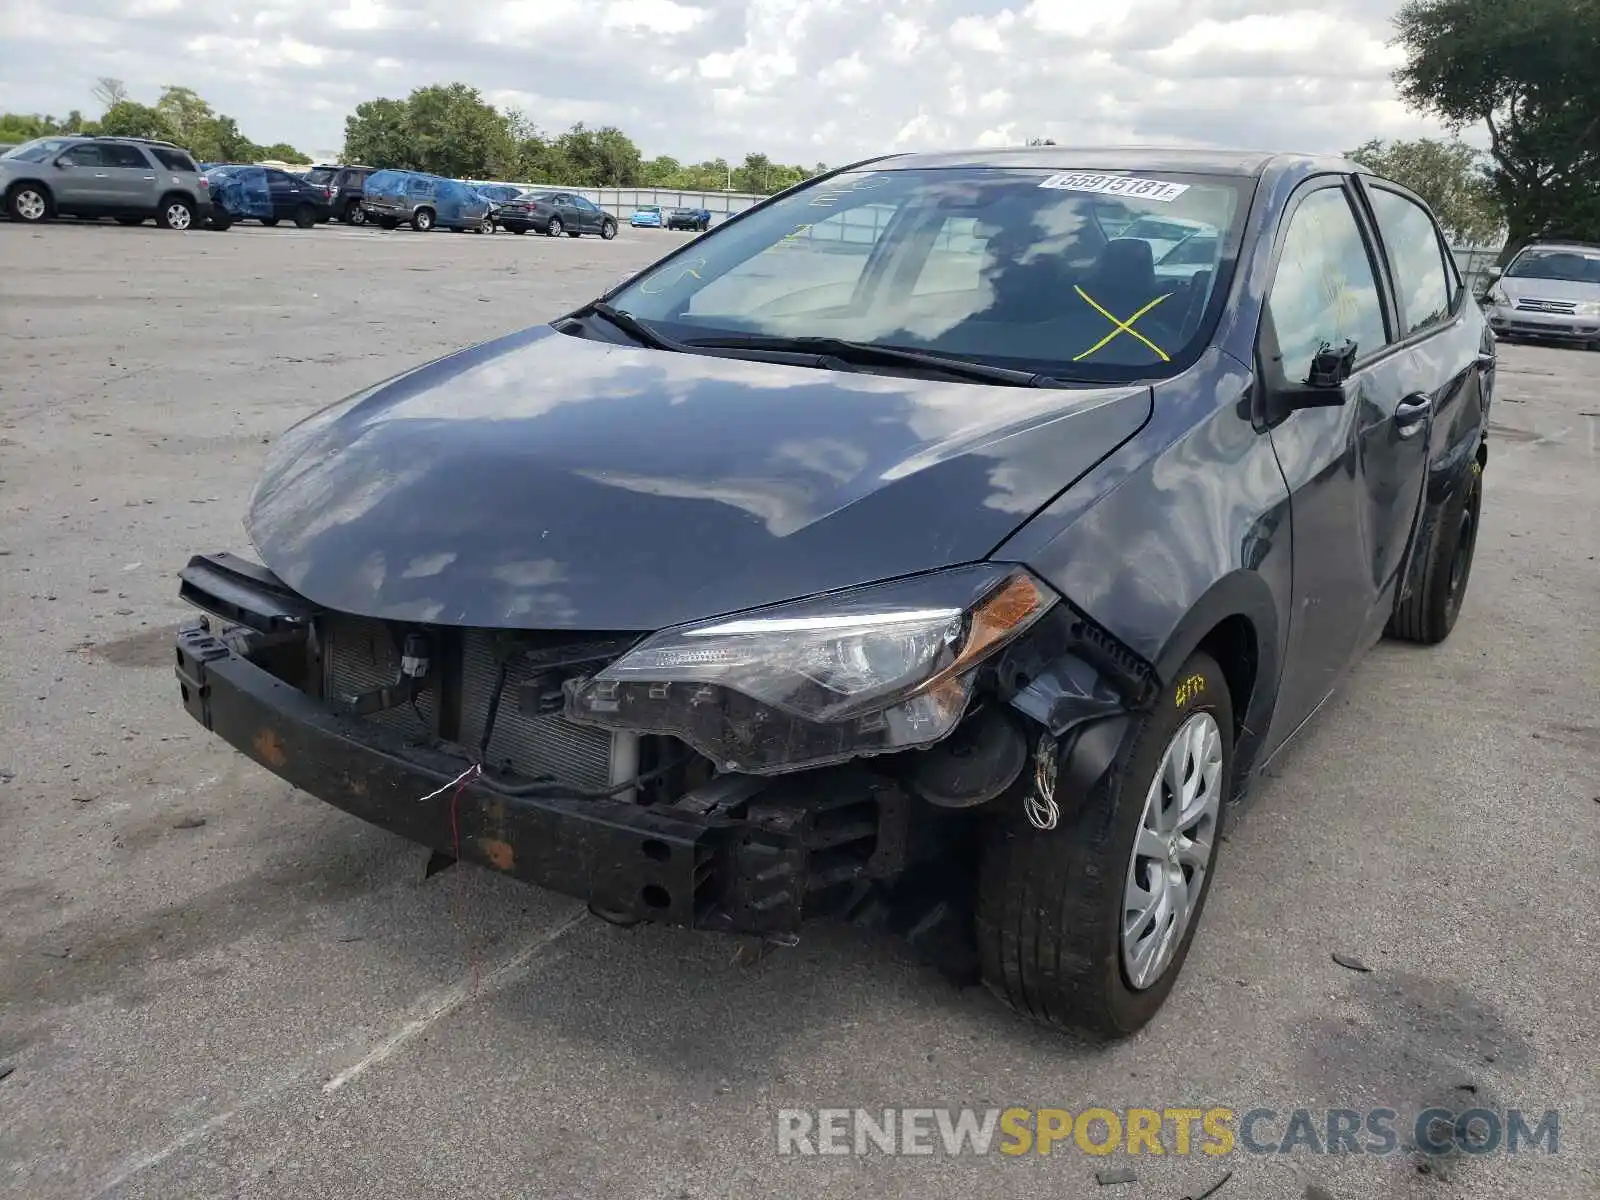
[1486,242,1600,350]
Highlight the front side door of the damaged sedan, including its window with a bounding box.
[1264,176,1429,744]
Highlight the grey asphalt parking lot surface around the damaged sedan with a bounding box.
[0,224,1600,1200]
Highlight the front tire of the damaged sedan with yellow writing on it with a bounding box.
[976,653,1234,1040]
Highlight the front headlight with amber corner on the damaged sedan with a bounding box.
[566,565,1056,774]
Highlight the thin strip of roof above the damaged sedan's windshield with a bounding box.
[859,146,1371,176]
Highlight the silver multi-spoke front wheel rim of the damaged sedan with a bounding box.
[1120,712,1222,992]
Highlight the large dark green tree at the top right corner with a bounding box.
[1395,0,1600,253]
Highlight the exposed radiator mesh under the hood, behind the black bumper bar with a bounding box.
[323,614,617,790]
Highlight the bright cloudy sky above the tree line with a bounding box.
[0,0,1437,163]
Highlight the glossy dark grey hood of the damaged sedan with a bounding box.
[246,326,1150,630]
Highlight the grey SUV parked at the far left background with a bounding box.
[0,136,211,229]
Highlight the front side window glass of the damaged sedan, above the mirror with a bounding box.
[1267,187,1389,381]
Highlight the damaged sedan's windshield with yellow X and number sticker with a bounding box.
[610,168,1253,379]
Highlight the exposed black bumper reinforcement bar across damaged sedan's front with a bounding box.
[176,627,907,938]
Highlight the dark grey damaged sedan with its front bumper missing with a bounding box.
[176,147,1494,1035]
